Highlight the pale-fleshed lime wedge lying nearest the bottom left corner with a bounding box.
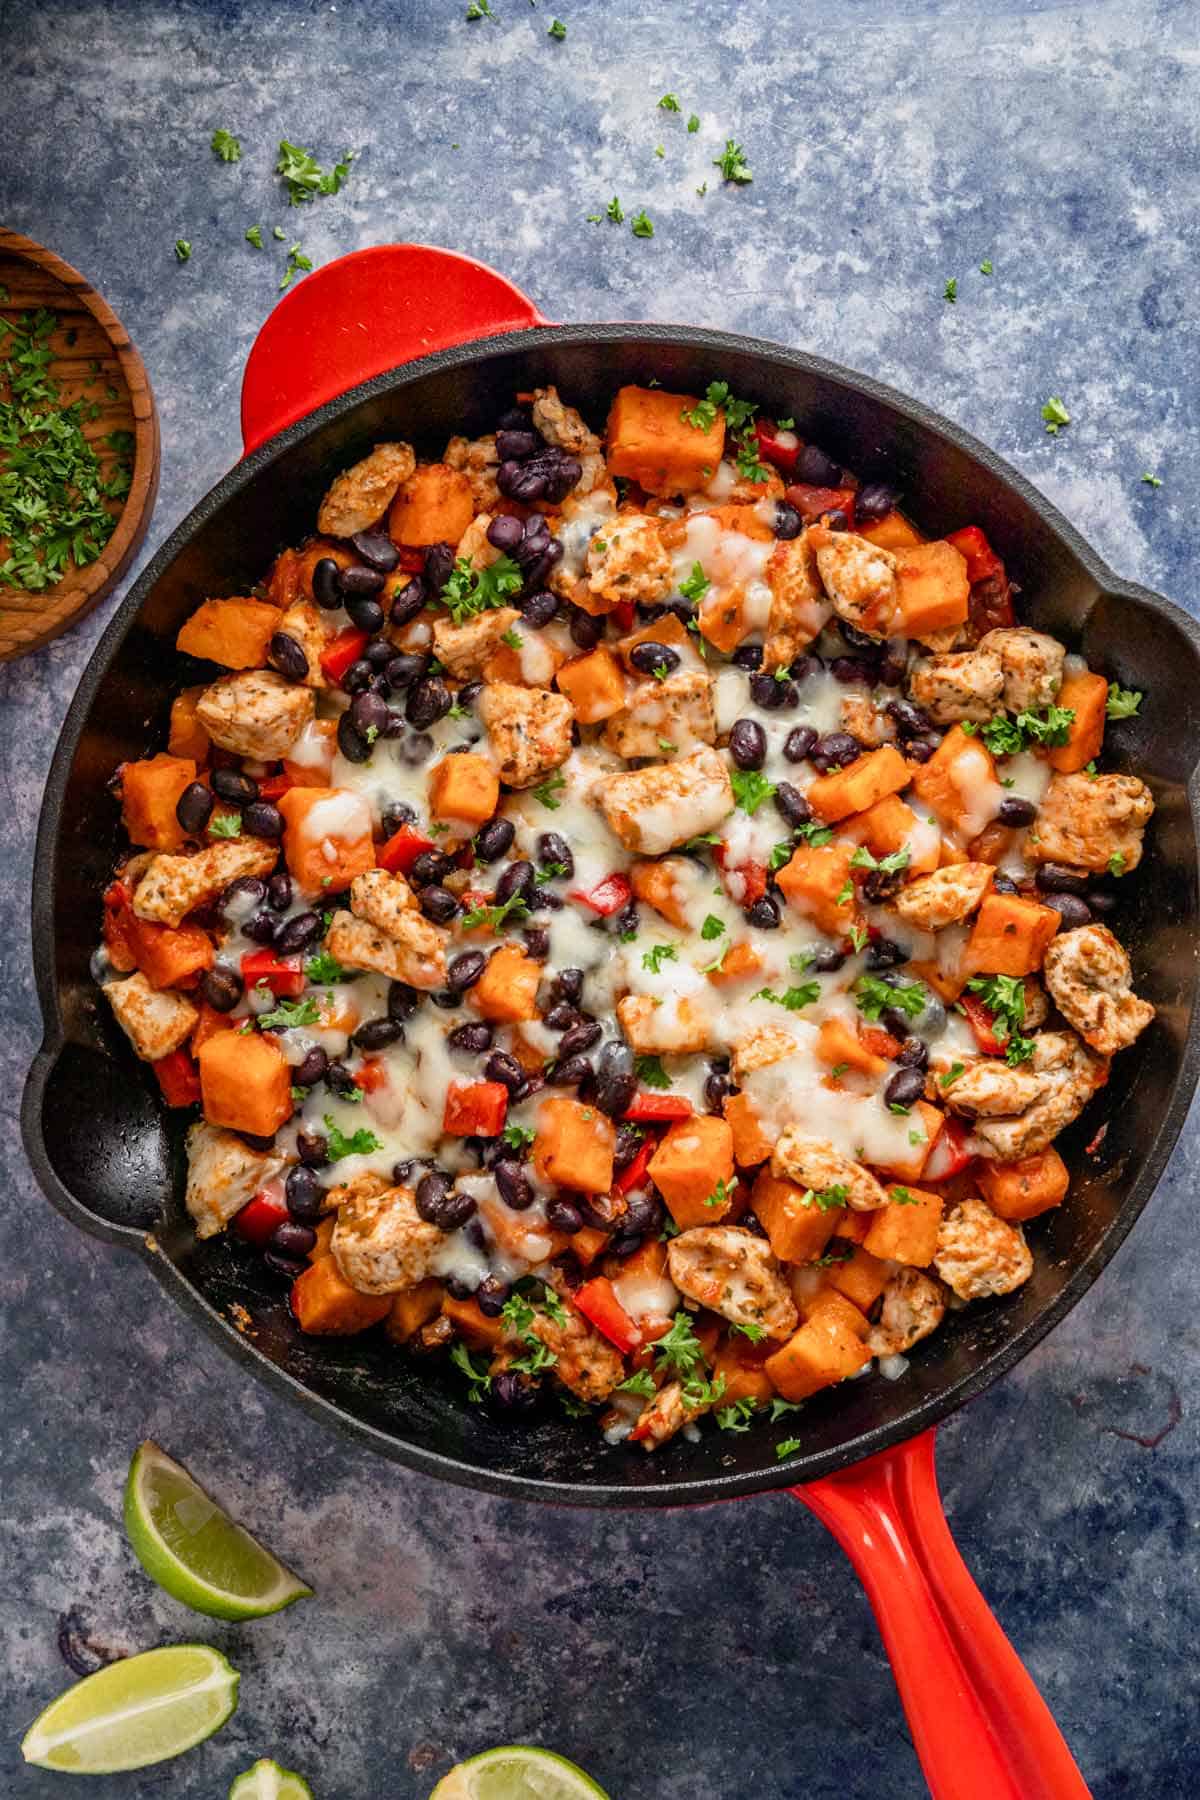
[22,1643,239,1775]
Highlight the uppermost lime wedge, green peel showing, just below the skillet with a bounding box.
[124,1440,313,1618]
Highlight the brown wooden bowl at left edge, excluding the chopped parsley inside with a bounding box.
[0,227,158,662]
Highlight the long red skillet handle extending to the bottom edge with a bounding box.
[792,1431,1088,1800]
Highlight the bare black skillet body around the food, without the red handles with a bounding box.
[25,326,1200,1505]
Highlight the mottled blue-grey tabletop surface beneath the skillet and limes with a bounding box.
[0,0,1200,1800]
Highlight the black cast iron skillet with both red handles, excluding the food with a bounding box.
[22,245,1200,1800]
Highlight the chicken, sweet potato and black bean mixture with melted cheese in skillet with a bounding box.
[97,383,1153,1453]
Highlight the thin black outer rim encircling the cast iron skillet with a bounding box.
[22,320,1200,1508]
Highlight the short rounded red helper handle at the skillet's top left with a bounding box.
[241,243,549,455]
